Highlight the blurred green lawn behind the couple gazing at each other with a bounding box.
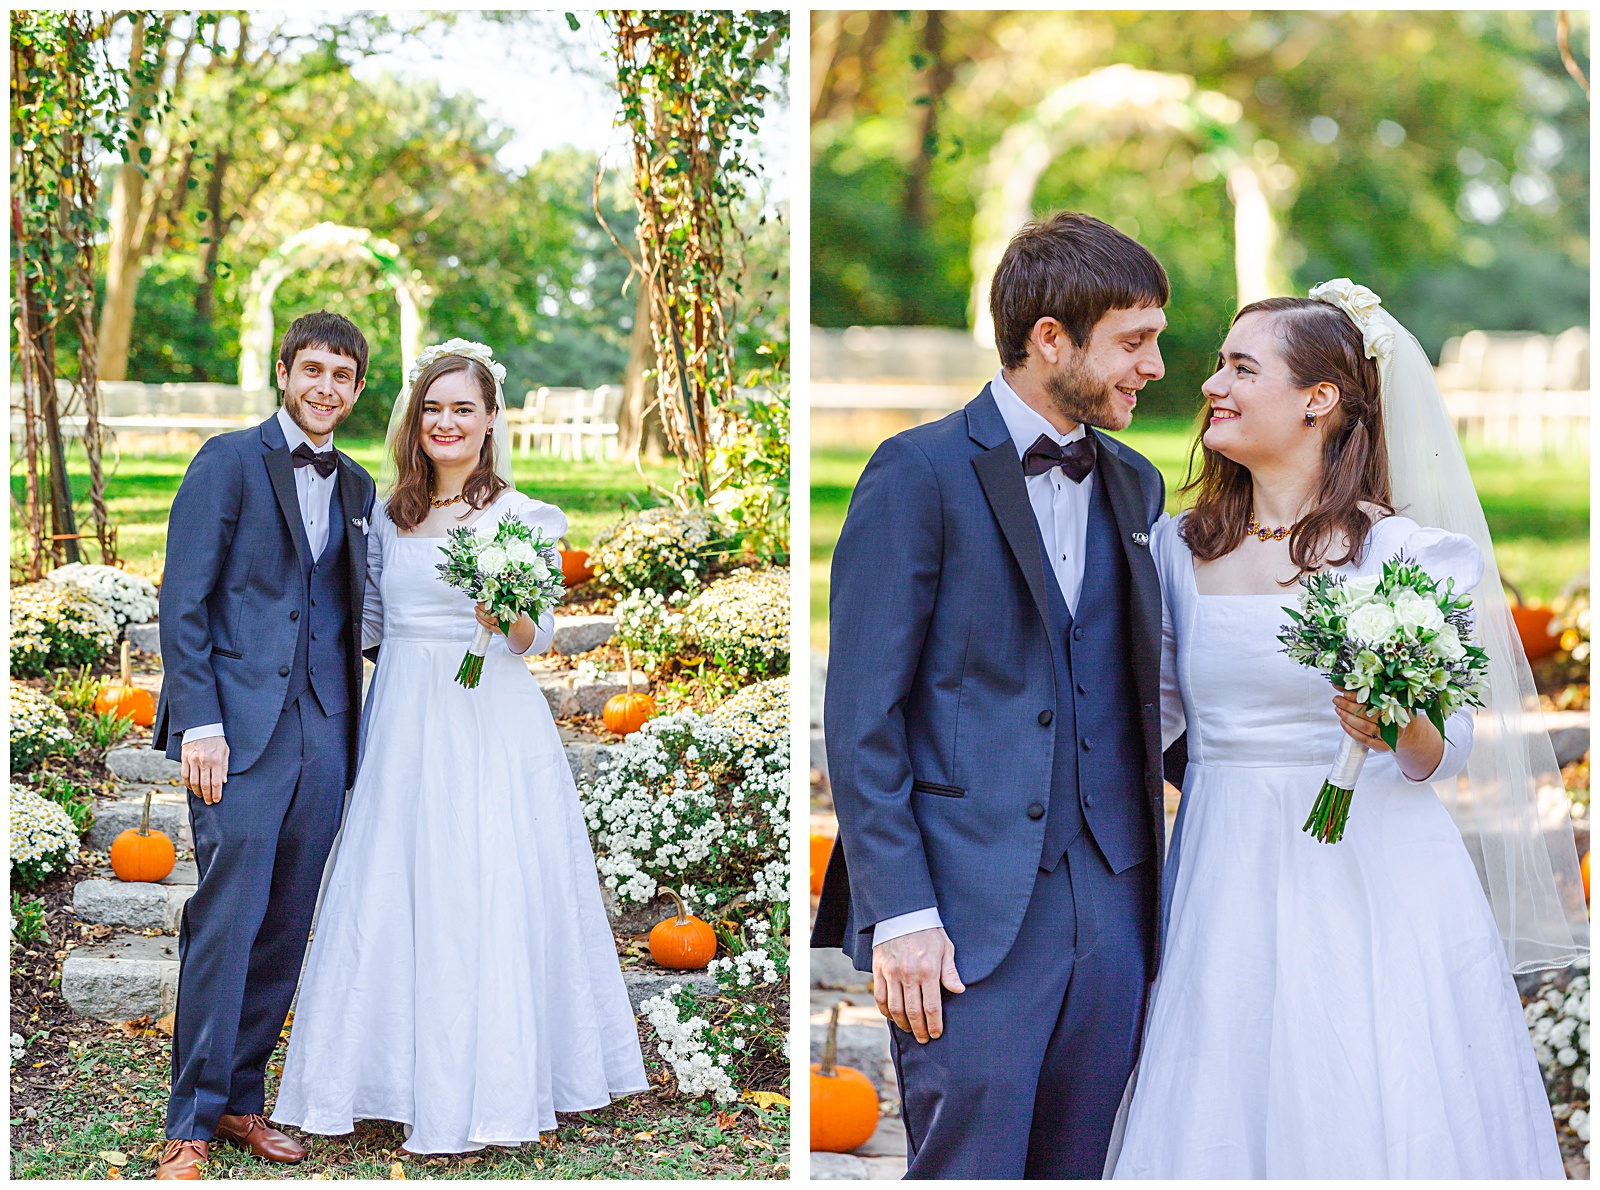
[811,424,1589,649]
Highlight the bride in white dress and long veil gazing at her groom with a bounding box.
[1106,280,1587,1179]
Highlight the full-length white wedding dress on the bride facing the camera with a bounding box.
[272,491,646,1153]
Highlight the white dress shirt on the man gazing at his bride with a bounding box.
[872,373,1094,945]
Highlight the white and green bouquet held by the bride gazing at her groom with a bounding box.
[1278,553,1490,843]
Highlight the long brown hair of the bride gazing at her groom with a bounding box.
[1181,298,1394,585]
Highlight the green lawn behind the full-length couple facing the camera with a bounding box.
[11,438,677,577]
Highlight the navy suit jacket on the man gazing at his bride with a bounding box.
[813,385,1165,984]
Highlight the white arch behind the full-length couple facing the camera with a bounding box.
[238,222,427,390]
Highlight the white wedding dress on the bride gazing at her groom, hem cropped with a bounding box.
[1107,517,1565,1179]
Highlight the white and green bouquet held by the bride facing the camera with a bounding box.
[438,517,566,689]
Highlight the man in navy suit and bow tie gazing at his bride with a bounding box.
[811,214,1168,1177]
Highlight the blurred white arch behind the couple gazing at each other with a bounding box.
[968,66,1286,347]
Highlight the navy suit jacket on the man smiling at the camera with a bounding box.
[154,414,376,777]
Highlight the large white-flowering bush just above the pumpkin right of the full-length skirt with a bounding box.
[582,678,789,912]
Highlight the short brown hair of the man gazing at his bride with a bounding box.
[989,211,1170,368]
